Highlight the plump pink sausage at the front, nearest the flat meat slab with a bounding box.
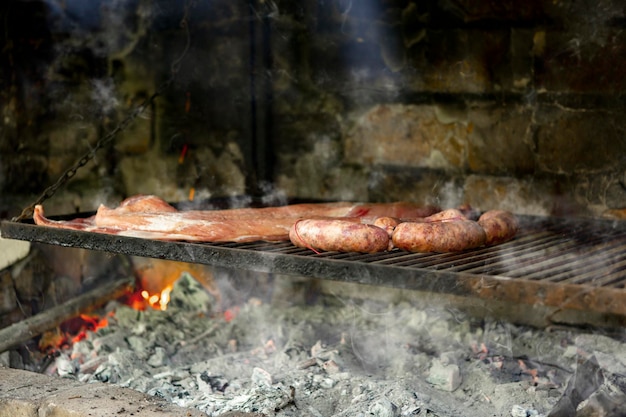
[289,219,389,253]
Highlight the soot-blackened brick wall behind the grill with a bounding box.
[0,0,626,216]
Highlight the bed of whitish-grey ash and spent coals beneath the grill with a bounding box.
[48,275,626,417]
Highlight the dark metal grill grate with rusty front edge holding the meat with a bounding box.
[1,216,626,315]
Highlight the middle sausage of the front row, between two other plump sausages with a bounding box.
[392,220,486,252]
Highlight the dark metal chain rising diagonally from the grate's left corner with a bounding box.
[11,0,193,222]
